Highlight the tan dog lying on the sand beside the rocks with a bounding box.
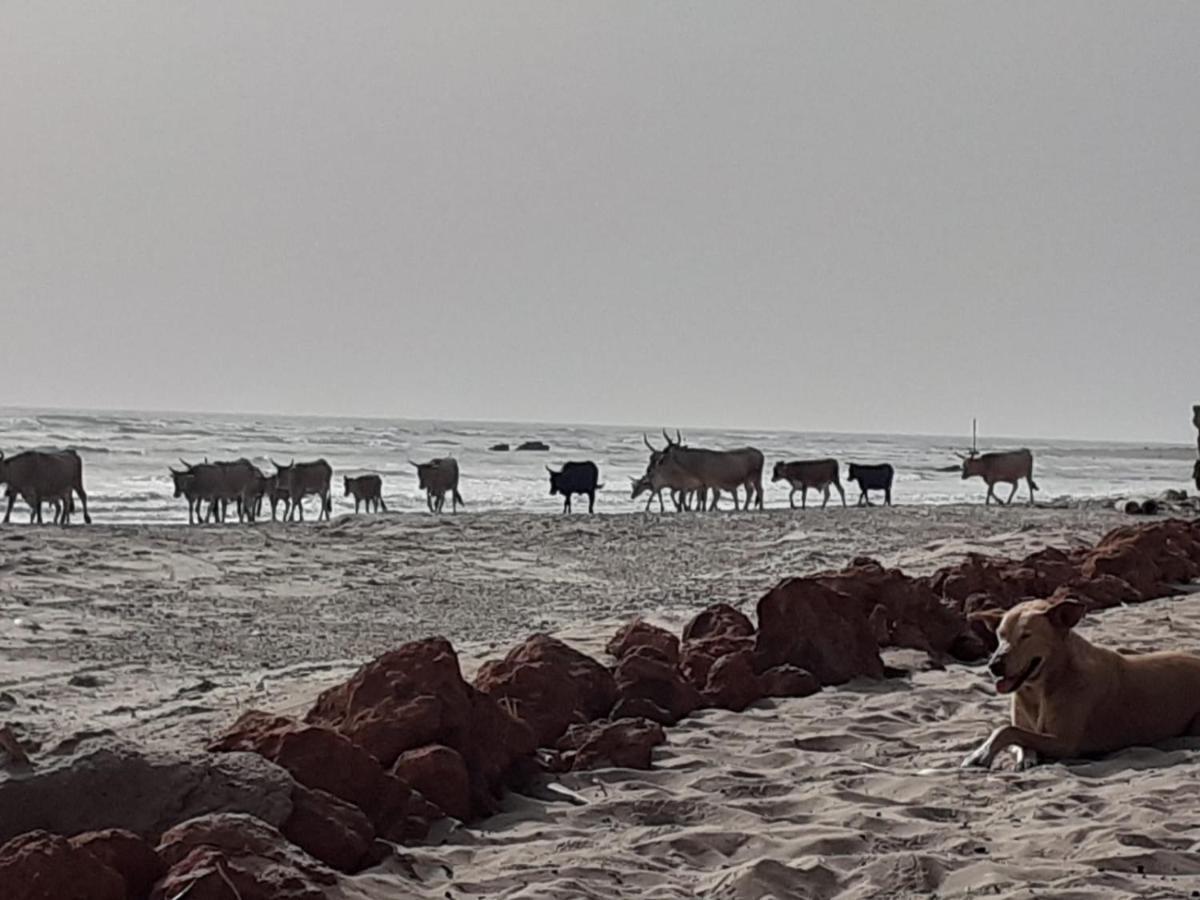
[962,600,1200,768]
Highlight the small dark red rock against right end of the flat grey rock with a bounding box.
[282,785,376,875]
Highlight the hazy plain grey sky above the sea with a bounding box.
[0,0,1200,443]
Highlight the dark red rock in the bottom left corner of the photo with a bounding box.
[0,832,126,900]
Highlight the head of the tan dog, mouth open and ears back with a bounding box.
[973,600,1087,694]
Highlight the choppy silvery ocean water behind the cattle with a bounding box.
[0,408,1196,523]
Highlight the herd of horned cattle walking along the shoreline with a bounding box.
[0,431,1038,524]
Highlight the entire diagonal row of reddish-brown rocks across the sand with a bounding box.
[0,521,1200,900]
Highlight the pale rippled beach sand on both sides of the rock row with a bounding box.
[7,506,1200,899]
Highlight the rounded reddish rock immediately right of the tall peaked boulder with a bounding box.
[475,635,617,746]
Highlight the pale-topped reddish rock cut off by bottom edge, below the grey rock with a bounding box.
[152,814,341,900]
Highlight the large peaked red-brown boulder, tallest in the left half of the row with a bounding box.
[305,637,536,816]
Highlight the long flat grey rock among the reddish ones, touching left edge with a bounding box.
[0,736,294,841]
